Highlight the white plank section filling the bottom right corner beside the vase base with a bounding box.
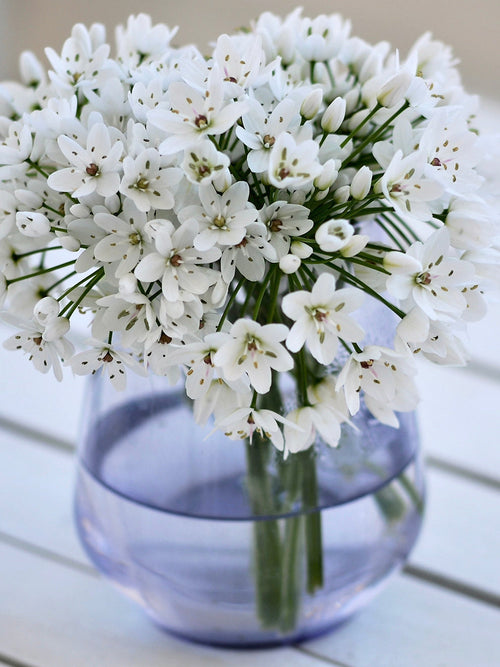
[305,577,500,667]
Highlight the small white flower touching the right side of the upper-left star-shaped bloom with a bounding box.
[120,148,182,213]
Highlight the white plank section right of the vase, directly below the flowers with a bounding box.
[418,365,500,480]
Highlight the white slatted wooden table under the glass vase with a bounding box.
[0,103,500,667]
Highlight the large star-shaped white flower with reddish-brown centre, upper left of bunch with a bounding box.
[47,123,123,197]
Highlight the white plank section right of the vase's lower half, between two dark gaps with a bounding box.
[410,470,500,596]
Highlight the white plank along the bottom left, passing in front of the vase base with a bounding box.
[0,544,322,667]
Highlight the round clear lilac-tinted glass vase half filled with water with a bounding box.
[75,375,423,647]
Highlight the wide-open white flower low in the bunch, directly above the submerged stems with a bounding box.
[214,318,293,394]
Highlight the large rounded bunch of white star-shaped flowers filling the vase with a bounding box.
[0,10,499,455]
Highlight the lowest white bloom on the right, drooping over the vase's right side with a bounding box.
[336,345,418,428]
